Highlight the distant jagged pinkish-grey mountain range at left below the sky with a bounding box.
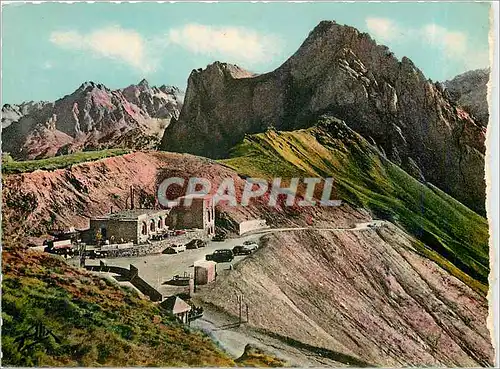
[2,80,182,160]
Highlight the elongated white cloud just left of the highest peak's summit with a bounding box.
[167,24,281,64]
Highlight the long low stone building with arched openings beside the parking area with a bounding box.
[82,209,170,244]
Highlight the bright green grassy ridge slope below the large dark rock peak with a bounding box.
[221,117,489,294]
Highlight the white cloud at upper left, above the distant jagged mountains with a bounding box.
[50,26,157,73]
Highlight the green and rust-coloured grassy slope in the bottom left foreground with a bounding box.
[2,251,236,367]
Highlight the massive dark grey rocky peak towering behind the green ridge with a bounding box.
[160,21,485,213]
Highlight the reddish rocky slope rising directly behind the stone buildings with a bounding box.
[2,152,324,243]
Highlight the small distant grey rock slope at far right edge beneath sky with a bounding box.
[443,68,490,127]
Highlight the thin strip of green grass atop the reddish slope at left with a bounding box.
[2,149,130,174]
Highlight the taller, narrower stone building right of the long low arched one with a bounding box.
[167,195,215,236]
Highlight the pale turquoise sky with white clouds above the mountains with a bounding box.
[2,3,489,103]
